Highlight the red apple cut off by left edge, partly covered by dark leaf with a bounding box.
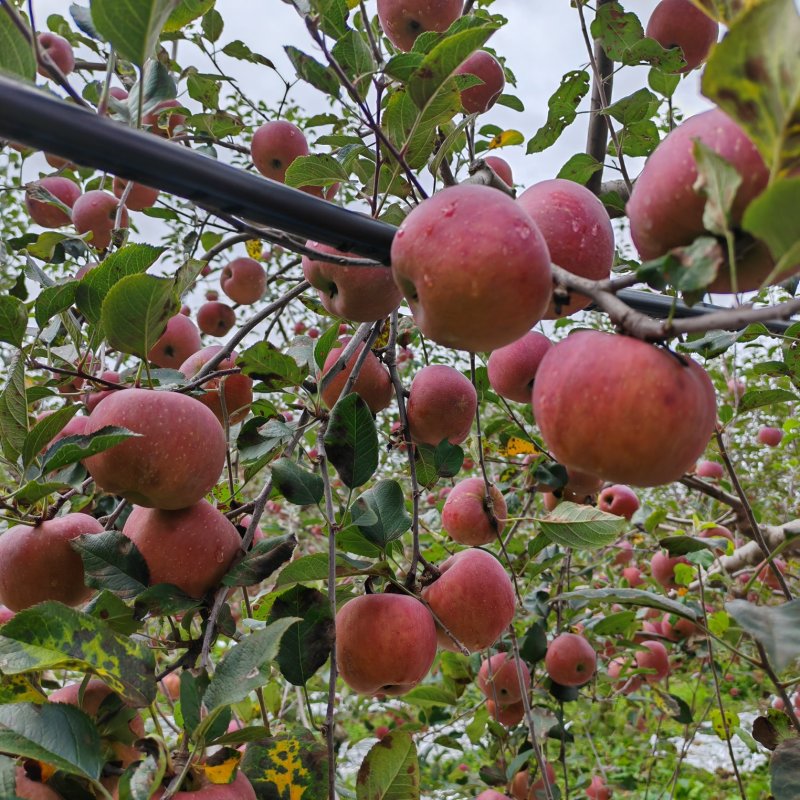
[0,514,103,611]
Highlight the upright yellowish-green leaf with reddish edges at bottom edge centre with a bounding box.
[356,731,420,800]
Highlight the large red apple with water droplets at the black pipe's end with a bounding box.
[391,184,552,351]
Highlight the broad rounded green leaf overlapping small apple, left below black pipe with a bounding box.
[101,275,180,358]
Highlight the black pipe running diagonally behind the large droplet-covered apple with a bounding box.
[0,76,791,333]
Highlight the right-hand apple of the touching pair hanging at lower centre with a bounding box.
[422,549,515,652]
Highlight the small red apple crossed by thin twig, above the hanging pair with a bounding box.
[442,478,508,547]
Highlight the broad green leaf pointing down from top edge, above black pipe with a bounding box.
[91,0,179,67]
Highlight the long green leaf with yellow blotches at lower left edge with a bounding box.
[0,601,156,708]
